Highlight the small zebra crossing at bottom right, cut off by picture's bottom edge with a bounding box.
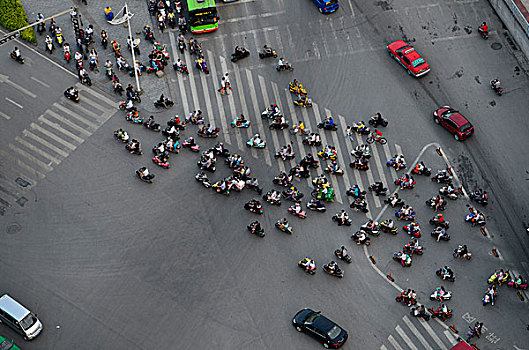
[380,316,458,350]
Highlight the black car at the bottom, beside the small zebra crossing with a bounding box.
[292,309,348,349]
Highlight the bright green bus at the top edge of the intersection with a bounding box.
[187,0,219,33]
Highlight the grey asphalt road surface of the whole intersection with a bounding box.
[0,0,529,349]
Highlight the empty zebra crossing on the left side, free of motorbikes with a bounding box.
[0,83,117,216]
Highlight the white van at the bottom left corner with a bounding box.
[0,294,42,340]
